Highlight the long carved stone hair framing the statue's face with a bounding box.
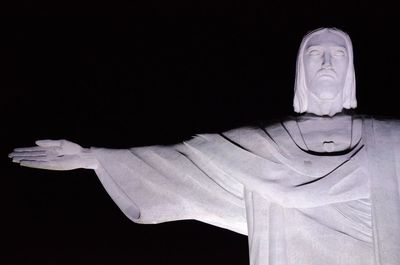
[293,28,357,113]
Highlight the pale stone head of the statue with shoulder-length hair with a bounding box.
[293,28,357,116]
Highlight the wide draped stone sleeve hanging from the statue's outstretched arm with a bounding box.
[92,136,247,235]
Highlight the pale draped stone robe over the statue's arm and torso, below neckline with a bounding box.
[92,117,400,265]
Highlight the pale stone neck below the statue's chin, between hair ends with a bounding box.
[307,93,343,117]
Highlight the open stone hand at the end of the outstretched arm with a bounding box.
[8,140,97,170]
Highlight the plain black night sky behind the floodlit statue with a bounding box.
[0,1,400,265]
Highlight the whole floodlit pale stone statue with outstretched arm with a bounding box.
[9,28,400,265]
